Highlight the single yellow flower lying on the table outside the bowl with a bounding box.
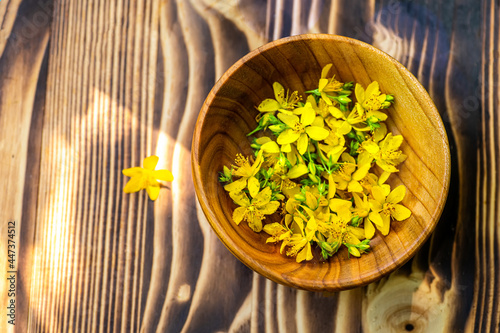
[122,155,174,200]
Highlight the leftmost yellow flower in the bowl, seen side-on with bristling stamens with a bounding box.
[224,150,264,194]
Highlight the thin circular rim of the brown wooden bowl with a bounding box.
[191,33,451,291]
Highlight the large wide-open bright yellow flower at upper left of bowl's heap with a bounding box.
[276,103,330,155]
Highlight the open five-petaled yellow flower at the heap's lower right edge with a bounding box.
[369,185,411,236]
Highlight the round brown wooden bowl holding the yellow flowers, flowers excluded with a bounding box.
[192,34,450,291]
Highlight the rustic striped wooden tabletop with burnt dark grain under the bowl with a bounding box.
[0,0,492,332]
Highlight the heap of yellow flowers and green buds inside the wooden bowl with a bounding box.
[219,64,411,262]
